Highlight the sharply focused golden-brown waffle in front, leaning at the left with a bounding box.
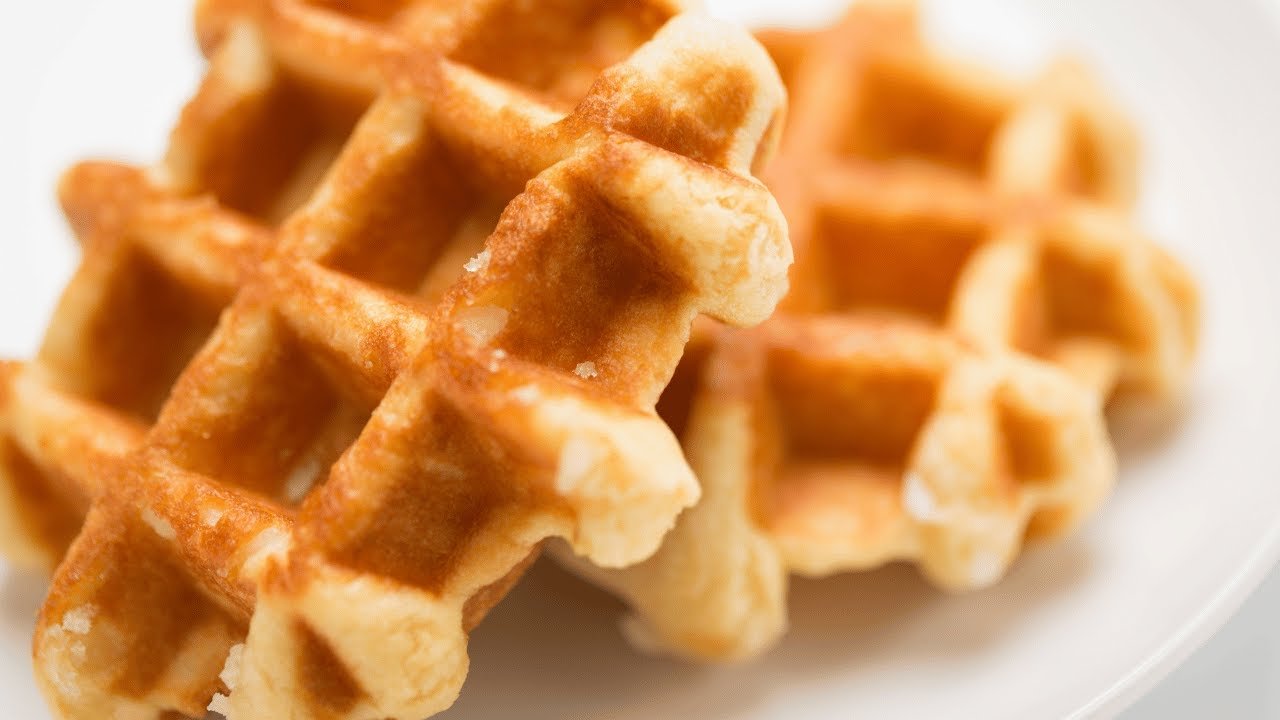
[0,0,790,720]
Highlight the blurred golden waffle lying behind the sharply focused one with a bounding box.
[563,3,1197,660]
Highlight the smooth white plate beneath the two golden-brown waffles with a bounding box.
[0,0,1280,720]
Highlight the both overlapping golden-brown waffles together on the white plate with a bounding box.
[0,0,1197,720]
